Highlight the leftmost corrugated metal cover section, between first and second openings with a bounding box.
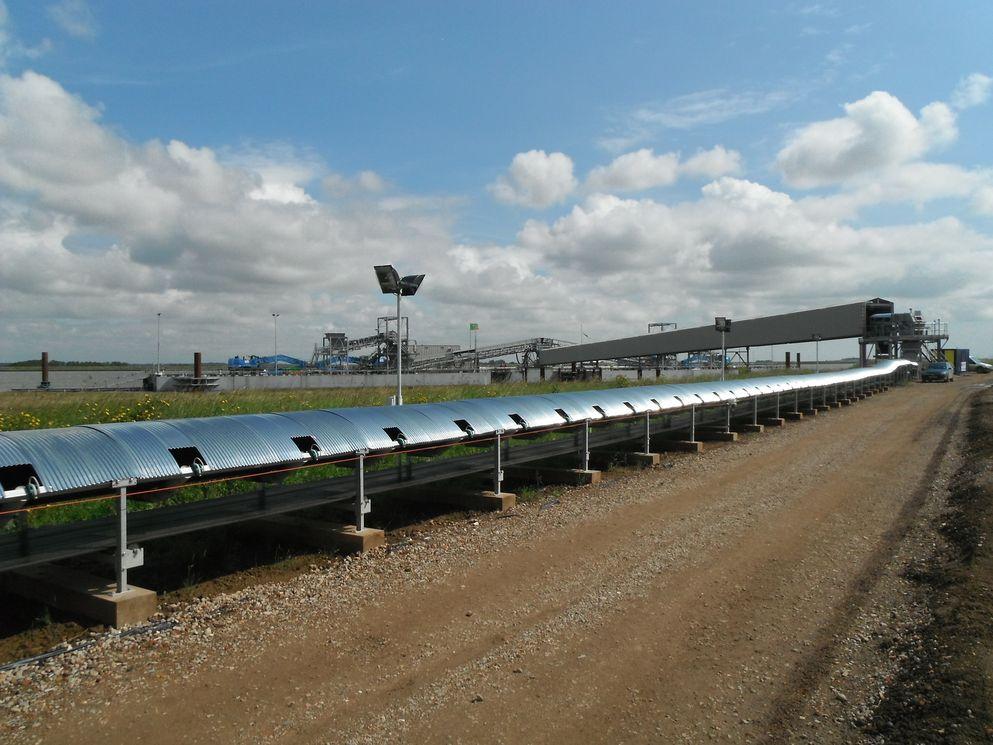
[3,427,138,492]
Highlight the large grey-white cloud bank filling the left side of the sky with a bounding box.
[0,72,458,356]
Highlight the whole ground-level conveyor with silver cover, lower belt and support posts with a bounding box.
[0,360,916,589]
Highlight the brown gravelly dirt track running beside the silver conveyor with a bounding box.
[0,383,974,743]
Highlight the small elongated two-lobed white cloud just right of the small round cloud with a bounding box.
[586,145,741,192]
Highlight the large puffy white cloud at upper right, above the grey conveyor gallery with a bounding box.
[776,91,957,188]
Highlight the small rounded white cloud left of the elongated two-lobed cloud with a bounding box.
[489,150,577,209]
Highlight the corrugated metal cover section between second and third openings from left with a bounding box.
[166,415,299,471]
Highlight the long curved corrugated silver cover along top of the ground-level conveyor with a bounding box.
[0,360,916,501]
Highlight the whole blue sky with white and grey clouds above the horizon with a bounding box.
[0,0,993,362]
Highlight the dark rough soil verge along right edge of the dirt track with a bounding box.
[865,389,993,743]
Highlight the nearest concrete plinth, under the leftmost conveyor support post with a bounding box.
[0,564,159,628]
